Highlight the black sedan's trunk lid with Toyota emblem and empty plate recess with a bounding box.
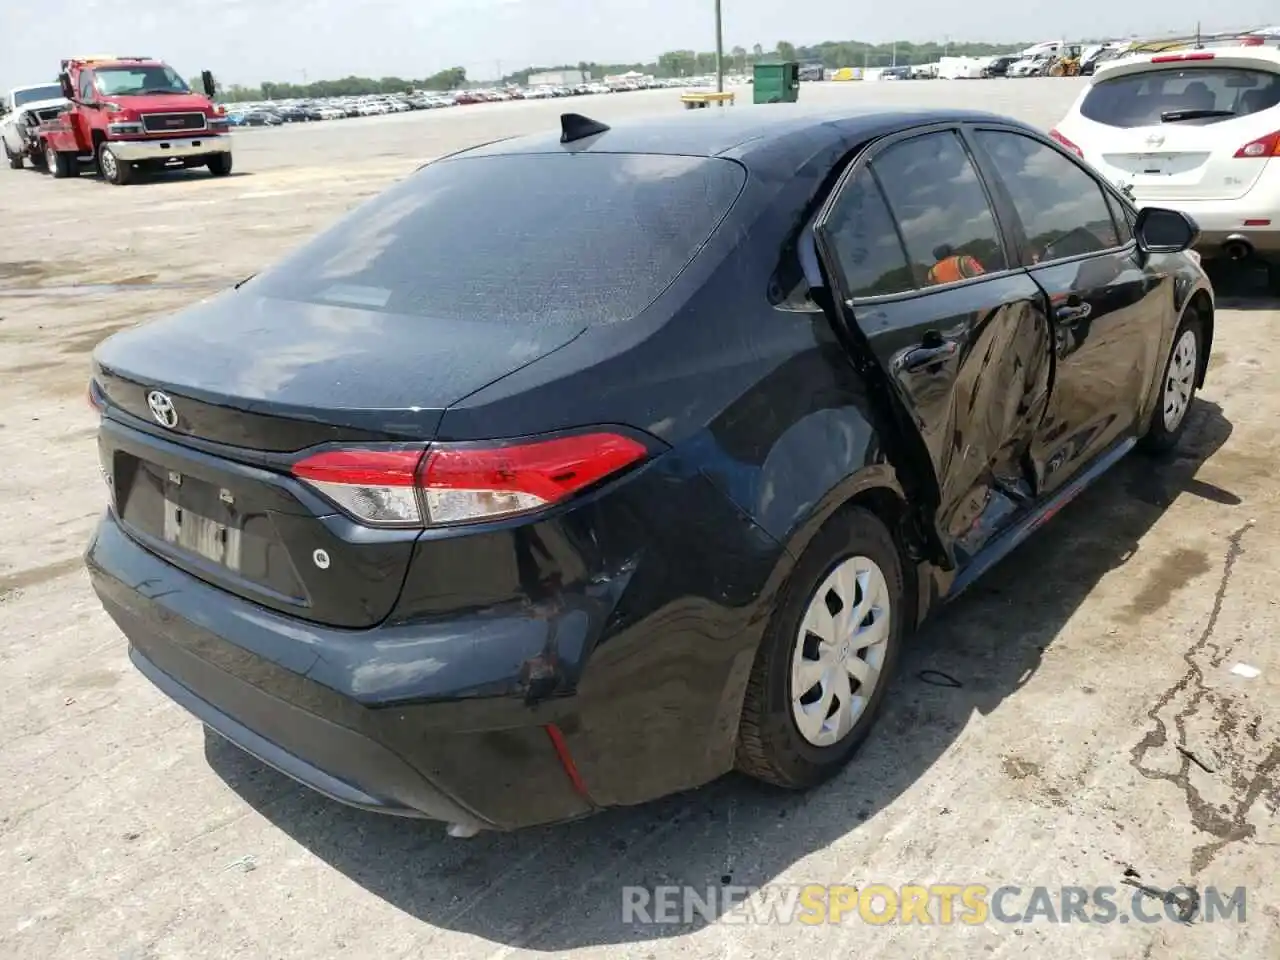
[93,288,580,627]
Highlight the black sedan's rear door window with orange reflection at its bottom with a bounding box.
[870,131,1007,287]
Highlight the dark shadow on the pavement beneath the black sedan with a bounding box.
[205,401,1239,954]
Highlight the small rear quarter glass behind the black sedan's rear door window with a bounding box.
[824,168,915,297]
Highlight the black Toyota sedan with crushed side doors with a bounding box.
[87,105,1213,833]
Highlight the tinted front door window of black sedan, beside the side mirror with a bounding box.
[977,131,1123,262]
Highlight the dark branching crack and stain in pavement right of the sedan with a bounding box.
[1129,520,1280,874]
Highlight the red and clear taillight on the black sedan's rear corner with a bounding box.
[292,433,649,527]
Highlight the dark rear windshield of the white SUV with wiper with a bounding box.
[1080,67,1280,127]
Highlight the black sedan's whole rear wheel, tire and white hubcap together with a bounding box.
[737,508,905,788]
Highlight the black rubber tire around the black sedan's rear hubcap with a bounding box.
[737,508,906,790]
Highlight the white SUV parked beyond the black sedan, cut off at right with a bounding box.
[1051,46,1280,293]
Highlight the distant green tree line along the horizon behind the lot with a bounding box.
[221,40,1028,102]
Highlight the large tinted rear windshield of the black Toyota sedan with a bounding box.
[253,152,746,325]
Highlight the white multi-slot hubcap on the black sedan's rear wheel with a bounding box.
[791,557,890,746]
